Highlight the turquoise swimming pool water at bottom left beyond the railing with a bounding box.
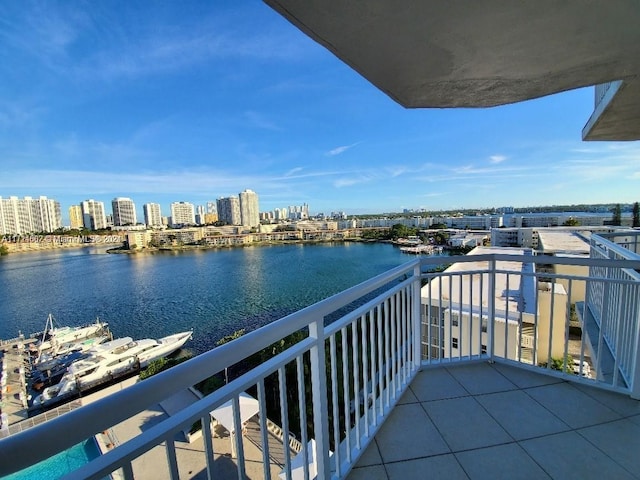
[2,438,100,480]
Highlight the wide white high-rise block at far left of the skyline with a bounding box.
[0,197,62,235]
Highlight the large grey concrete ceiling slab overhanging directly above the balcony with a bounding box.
[265,0,640,108]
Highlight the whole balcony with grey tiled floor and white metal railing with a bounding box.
[0,232,640,480]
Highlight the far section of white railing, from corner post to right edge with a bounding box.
[422,249,640,397]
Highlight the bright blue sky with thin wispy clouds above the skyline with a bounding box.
[0,0,640,220]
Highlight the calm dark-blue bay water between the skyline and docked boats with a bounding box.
[0,243,444,354]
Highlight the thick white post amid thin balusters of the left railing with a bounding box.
[308,317,331,478]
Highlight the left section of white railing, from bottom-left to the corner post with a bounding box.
[0,260,420,479]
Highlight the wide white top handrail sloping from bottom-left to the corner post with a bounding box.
[0,259,420,475]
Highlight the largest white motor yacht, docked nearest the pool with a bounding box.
[33,331,193,408]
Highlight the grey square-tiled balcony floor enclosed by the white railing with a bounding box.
[348,363,640,480]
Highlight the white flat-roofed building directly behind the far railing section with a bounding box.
[422,247,567,363]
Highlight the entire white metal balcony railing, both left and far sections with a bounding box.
[0,249,640,479]
